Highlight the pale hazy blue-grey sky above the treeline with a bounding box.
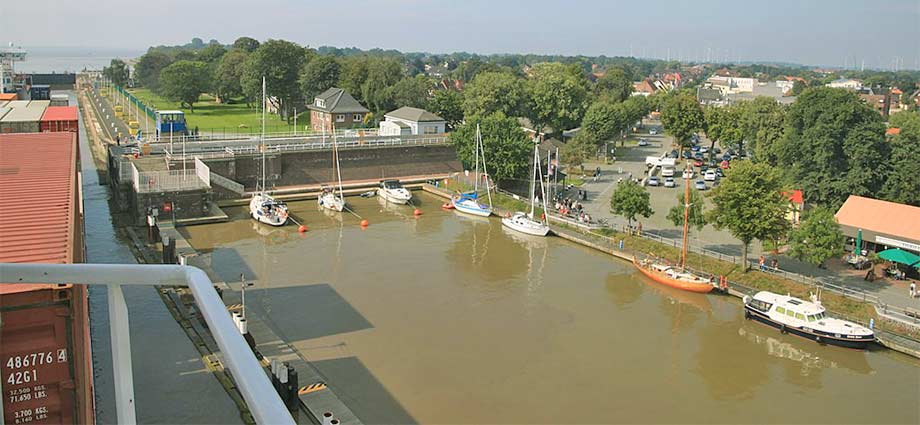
[0,0,920,69]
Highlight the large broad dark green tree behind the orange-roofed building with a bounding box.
[774,87,889,208]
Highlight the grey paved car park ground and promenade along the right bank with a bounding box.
[572,122,920,310]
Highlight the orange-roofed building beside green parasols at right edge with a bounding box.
[834,195,920,254]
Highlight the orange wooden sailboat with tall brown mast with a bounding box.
[633,164,715,294]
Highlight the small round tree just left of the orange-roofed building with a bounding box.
[789,207,844,267]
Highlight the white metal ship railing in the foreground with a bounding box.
[0,263,294,424]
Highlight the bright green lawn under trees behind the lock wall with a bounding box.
[122,88,310,133]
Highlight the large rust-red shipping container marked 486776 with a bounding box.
[0,133,95,424]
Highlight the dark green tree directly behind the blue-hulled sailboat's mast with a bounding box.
[450,112,533,182]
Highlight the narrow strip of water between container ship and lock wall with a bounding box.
[70,94,241,424]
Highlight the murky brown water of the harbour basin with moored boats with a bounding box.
[183,194,920,423]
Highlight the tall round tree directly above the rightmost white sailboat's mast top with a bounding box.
[526,63,588,133]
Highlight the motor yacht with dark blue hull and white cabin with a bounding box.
[744,291,875,348]
